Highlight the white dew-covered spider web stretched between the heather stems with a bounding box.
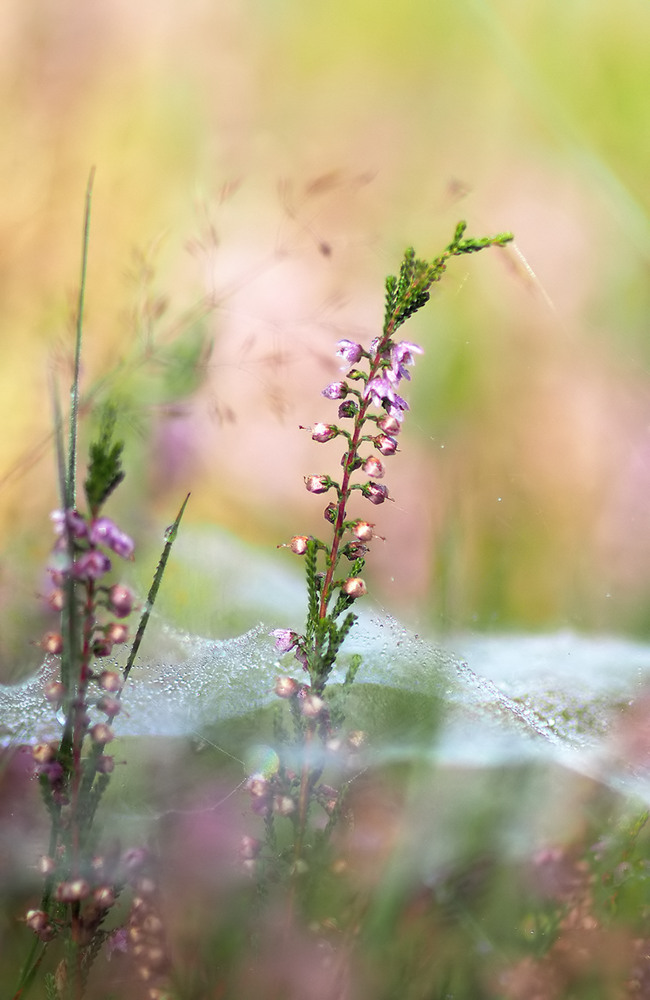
[0,600,650,801]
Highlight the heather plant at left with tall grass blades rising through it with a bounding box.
[13,175,187,1000]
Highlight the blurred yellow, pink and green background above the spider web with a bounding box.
[0,0,650,676]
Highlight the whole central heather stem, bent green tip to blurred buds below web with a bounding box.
[260,223,512,892]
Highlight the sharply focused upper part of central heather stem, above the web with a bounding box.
[274,223,512,695]
